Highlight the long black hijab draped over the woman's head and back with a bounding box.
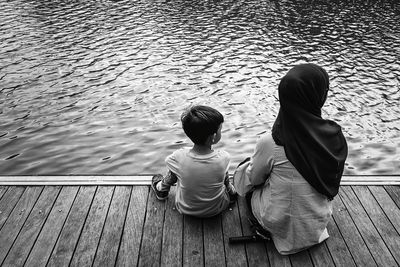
[272,64,347,199]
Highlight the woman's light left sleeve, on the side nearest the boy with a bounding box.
[233,136,274,196]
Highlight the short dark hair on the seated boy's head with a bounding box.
[181,105,224,145]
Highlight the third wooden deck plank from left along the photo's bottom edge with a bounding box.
[48,186,96,266]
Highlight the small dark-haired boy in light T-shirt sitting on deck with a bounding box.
[151,106,237,217]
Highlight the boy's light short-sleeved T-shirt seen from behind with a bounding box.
[165,148,230,217]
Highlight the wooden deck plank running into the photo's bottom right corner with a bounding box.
[352,186,400,265]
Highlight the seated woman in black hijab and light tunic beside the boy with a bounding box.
[234,64,347,255]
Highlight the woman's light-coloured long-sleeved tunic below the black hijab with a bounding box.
[234,135,332,255]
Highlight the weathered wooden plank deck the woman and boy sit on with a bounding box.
[0,185,400,267]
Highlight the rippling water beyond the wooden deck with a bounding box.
[0,0,400,175]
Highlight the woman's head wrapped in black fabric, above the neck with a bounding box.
[278,63,329,116]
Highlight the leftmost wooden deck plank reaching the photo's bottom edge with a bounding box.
[3,186,61,266]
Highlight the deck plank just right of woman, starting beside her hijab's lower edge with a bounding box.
[339,186,397,266]
